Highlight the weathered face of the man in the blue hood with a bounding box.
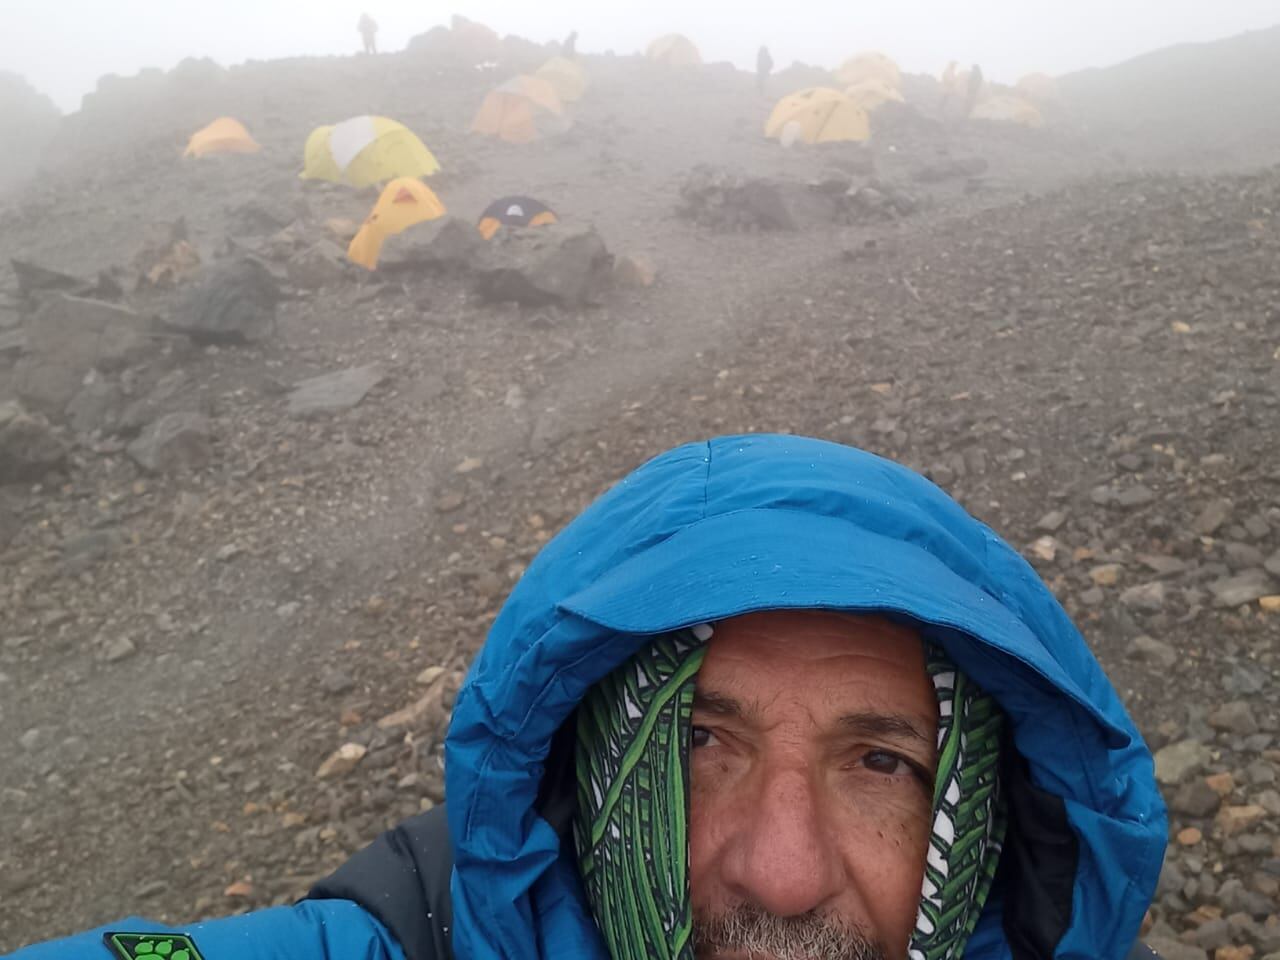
[690,611,938,960]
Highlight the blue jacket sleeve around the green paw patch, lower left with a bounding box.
[4,900,404,960]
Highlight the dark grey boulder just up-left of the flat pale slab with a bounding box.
[168,257,280,343]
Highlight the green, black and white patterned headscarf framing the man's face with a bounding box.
[573,626,1005,960]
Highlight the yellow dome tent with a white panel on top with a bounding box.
[302,116,440,187]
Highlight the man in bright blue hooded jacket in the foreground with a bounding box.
[7,435,1166,960]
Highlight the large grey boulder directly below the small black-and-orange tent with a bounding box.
[479,224,612,307]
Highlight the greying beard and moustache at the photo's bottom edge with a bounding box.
[694,904,884,960]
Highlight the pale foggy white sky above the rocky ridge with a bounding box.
[0,0,1280,110]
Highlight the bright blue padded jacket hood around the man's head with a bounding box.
[445,435,1166,960]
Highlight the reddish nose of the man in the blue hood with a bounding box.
[722,771,846,916]
